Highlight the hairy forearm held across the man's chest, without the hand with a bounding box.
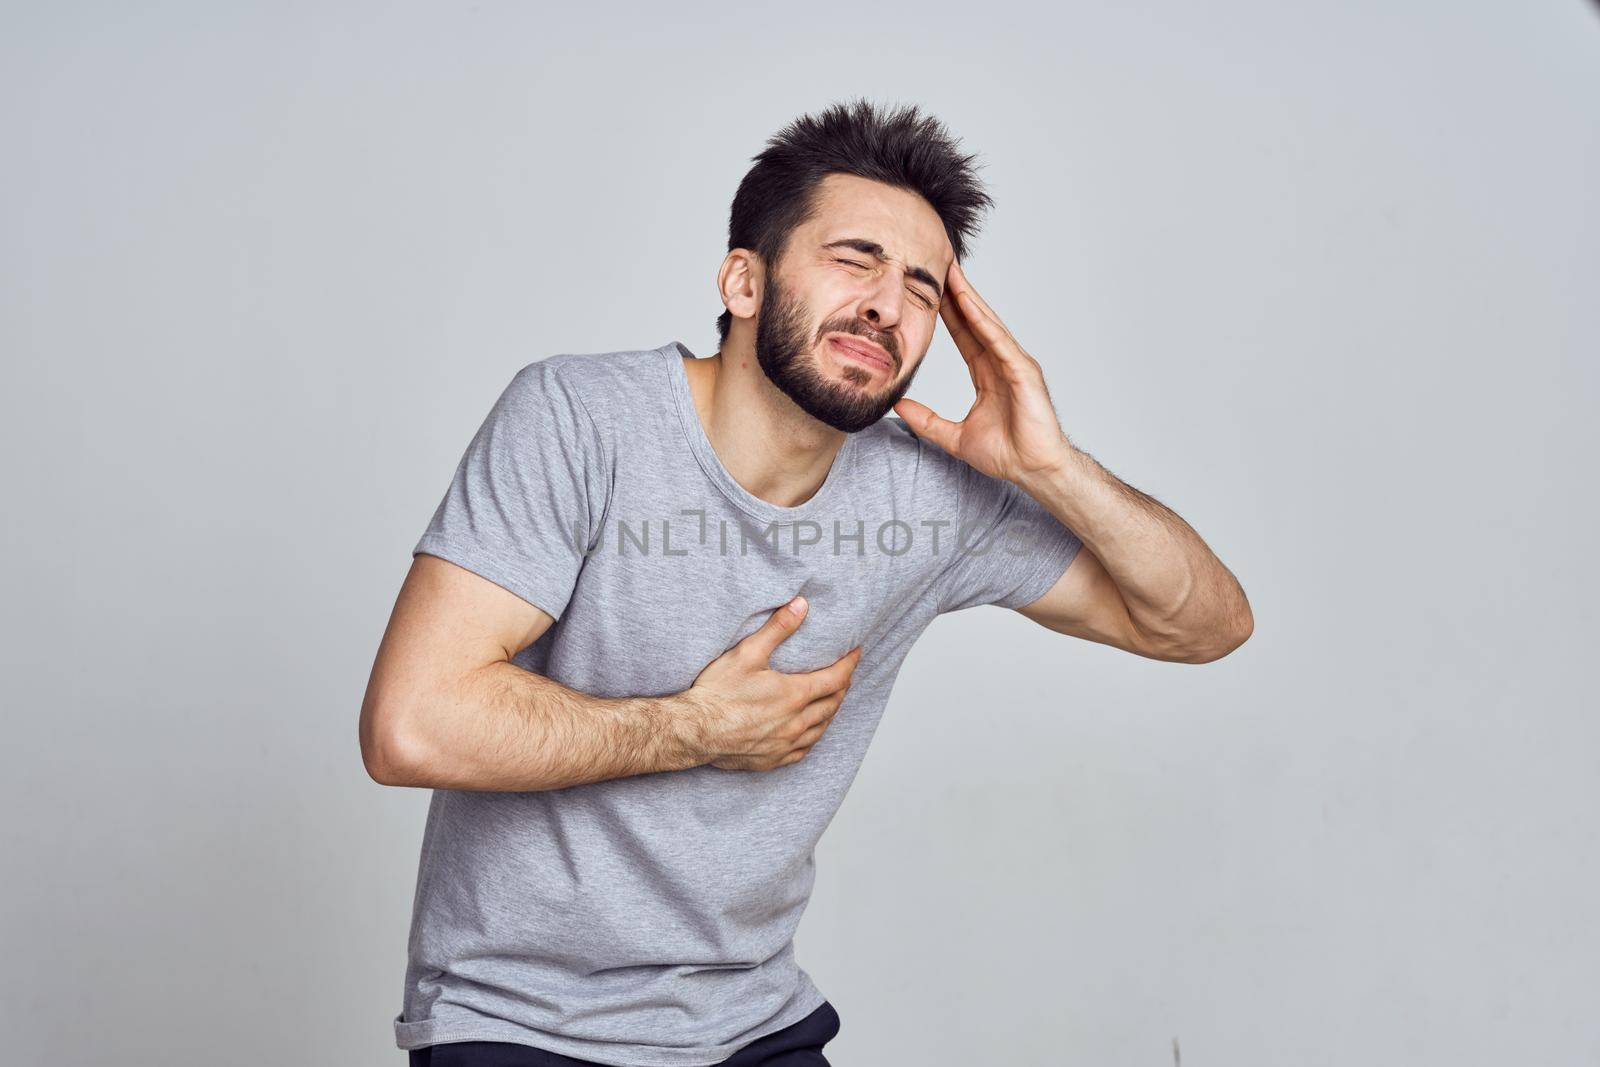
[387,662,701,790]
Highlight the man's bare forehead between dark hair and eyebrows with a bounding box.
[800,174,955,268]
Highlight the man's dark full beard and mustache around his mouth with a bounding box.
[755,274,920,434]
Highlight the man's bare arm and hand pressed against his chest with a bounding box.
[358,553,861,790]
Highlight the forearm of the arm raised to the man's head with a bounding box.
[1018,442,1253,651]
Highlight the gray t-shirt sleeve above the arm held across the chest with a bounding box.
[411,362,608,619]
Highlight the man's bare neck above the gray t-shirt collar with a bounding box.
[683,338,848,507]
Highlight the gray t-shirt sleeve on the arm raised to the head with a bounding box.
[936,462,1083,614]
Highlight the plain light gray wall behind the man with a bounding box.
[0,0,1600,1067]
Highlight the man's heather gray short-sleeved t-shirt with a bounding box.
[394,341,1080,1067]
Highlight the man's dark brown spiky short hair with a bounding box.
[717,99,994,342]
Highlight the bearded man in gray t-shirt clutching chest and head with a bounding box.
[360,101,1251,1067]
